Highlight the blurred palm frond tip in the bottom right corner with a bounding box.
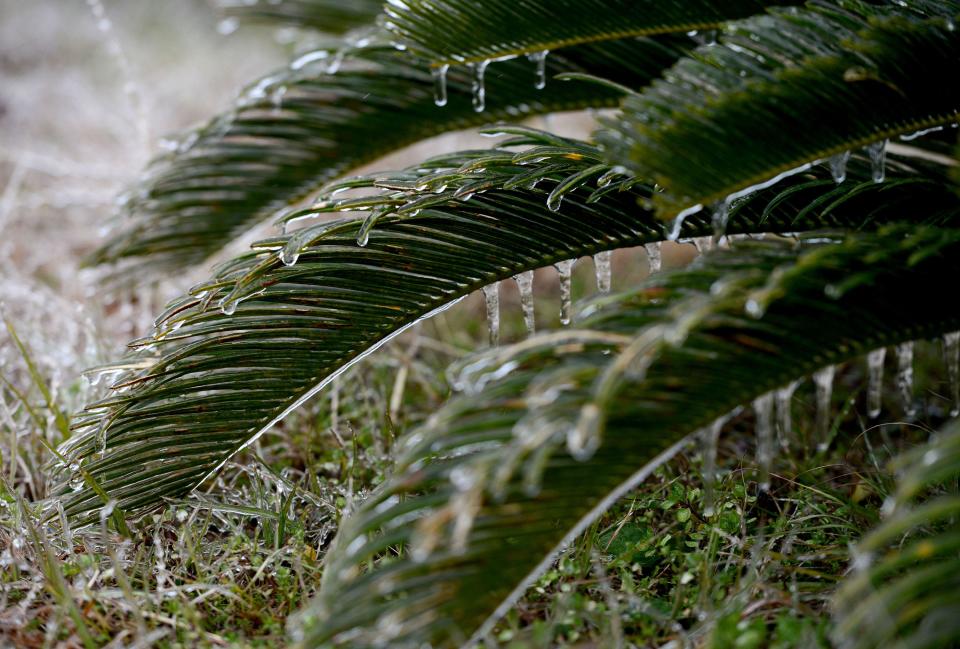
[834,422,960,649]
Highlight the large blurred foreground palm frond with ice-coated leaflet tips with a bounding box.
[304,227,960,647]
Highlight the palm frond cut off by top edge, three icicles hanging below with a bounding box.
[384,0,793,66]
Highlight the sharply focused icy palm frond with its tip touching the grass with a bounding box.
[54,130,960,514]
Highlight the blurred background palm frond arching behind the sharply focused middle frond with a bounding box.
[87,39,689,278]
